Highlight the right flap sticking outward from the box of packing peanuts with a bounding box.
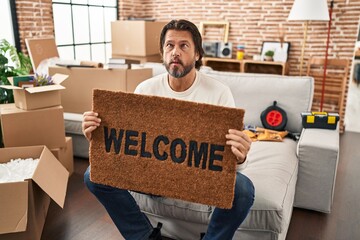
[32,147,69,208]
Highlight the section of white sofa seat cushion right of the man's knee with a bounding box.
[241,138,298,233]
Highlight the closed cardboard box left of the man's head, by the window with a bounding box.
[111,21,167,56]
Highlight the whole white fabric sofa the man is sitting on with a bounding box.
[65,64,339,240]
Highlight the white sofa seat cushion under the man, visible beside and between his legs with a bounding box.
[132,139,298,233]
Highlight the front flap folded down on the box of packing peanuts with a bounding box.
[0,181,28,234]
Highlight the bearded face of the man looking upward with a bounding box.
[163,30,199,78]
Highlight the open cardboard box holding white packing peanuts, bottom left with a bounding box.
[0,146,69,240]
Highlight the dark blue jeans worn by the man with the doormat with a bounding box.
[84,167,255,240]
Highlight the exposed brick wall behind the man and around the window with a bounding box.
[16,0,360,131]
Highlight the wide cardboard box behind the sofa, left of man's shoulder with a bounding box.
[49,66,152,114]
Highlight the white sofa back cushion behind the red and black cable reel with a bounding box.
[201,69,314,133]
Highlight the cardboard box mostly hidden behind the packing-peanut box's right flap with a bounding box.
[51,137,74,175]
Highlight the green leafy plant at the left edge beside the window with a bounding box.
[0,39,32,104]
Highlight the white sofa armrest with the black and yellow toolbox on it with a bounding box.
[294,128,340,213]
